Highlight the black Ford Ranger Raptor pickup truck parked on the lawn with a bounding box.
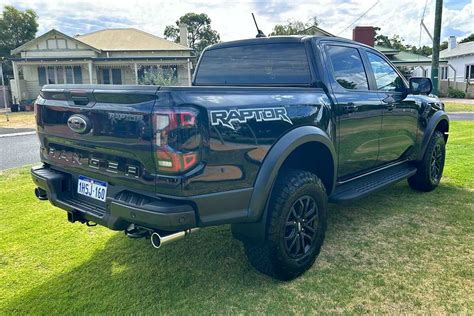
[32,37,449,280]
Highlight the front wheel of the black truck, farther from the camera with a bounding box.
[408,131,446,192]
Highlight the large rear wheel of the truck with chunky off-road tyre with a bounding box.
[244,170,327,280]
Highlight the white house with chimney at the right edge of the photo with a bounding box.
[416,36,474,98]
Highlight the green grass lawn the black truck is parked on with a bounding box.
[0,122,474,315]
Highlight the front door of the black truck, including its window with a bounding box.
[367,51,418,164]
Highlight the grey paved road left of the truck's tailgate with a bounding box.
[0,134,40,170]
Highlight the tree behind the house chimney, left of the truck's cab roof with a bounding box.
[164,13,220,55]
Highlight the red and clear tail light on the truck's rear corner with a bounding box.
[153,108,201,174]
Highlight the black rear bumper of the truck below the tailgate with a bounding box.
[31,166,197,231]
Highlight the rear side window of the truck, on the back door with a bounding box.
[326,45,369,90]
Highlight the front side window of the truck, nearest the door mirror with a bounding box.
[367,52,406,92]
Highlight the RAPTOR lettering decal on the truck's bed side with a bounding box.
[210,107,293,129]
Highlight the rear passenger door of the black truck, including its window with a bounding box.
[325,44,383,180]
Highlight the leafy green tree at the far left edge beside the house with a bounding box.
[0,6,38,57]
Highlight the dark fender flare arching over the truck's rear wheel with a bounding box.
[232,126,337,242]
